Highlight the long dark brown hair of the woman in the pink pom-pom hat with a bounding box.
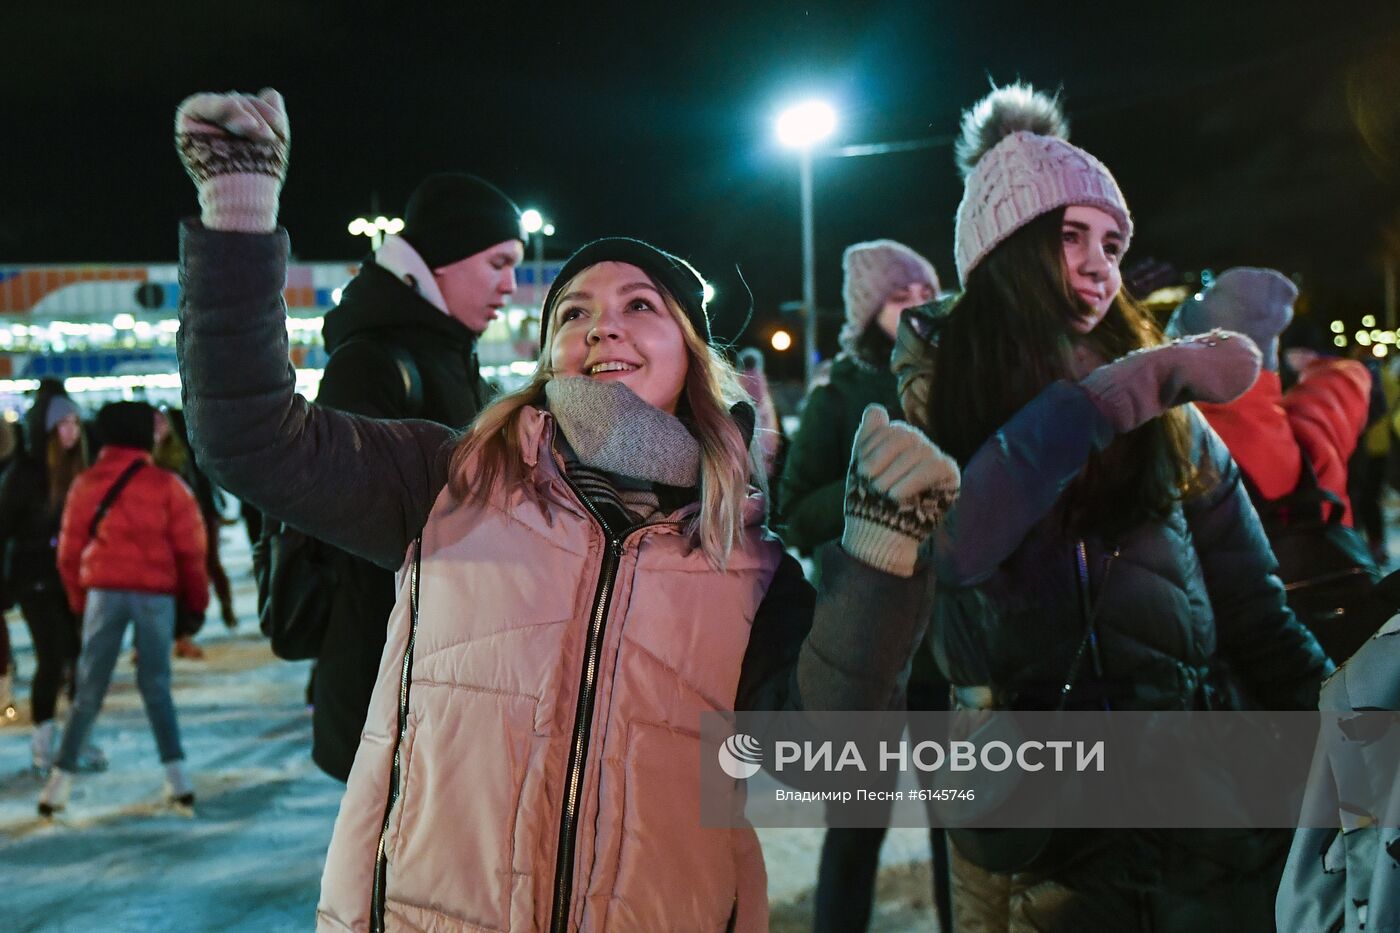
[928,210,1201,534]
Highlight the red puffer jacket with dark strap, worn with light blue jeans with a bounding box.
[59,444,209,615]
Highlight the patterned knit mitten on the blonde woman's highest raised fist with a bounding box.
[175,87,291,233]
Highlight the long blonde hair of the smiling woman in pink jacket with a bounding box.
[448,266,763,567]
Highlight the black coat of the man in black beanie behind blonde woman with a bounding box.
[311,252,490,780]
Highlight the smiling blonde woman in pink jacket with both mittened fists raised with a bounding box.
[176,91,958,932]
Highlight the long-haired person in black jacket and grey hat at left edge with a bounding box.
[0,384,88,773]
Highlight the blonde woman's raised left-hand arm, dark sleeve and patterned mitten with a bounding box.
[176,91,452,567]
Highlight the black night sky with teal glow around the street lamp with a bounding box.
[0,0,1400,361]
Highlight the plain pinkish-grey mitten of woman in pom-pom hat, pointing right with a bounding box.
[1079,329,1260,433]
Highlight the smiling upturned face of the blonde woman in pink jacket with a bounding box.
[549,262,689,415]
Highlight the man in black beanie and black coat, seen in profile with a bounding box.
[311,172,525,780]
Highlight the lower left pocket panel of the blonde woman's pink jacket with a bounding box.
[386,682,536,930]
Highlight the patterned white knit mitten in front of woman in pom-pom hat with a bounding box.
[841,405,960,577]
